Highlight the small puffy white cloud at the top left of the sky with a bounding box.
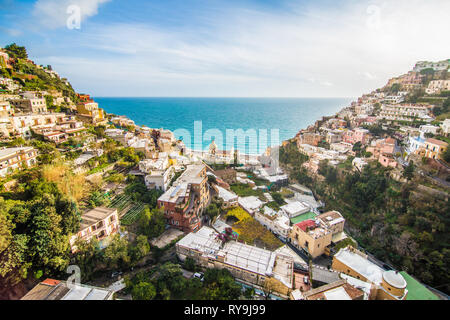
[33,0,110,28]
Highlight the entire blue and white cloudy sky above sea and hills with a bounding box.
[0,0,450,97]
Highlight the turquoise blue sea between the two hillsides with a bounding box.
[95,97,352,154]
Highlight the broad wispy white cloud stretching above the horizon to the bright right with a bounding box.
[40,0,450,96]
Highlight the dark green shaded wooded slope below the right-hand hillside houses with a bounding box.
[284,147,450,292]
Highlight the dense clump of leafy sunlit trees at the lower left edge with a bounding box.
[0,173,80,289]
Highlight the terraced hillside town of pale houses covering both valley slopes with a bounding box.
[0,44,450,300]
